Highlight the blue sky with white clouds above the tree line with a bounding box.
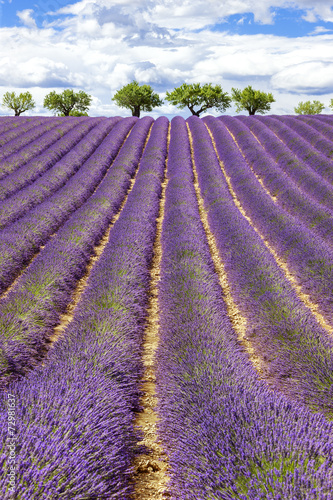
[0,0,333,117]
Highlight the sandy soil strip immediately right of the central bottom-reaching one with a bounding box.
[187,124,265,375]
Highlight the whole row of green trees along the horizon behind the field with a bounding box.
[2,85,333,117]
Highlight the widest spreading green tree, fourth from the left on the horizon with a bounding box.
[166,83,231,116]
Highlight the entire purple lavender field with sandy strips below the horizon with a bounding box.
[0,115,333,500]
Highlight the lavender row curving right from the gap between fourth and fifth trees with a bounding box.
[219,117,333,245]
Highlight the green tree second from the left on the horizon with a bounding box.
[44,89,92,116]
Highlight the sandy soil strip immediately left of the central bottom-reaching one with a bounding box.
[48,125,152,345]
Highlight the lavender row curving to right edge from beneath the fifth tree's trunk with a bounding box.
[235,117,333,215]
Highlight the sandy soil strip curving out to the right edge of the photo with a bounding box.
[207,123,333,335]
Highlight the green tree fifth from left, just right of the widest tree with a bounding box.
[231,85,275,115]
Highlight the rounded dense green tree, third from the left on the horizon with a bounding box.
[112,80,163,118]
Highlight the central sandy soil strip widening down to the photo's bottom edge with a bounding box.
[132,124,170,500]
